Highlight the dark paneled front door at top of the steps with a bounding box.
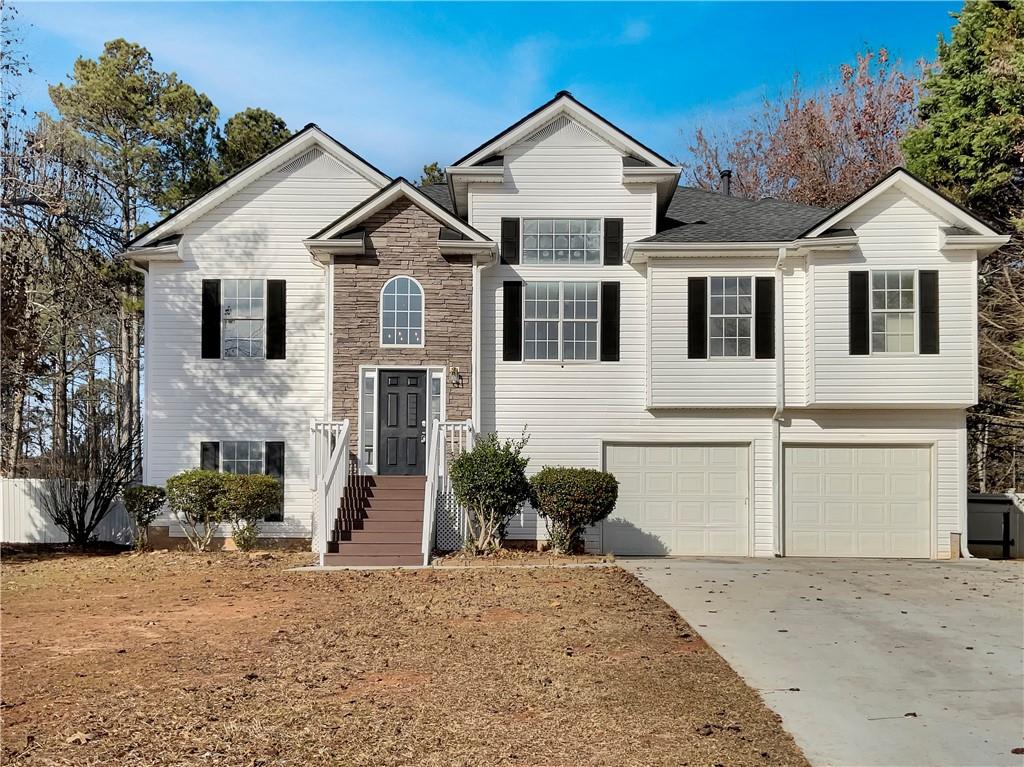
[377,370,427,474]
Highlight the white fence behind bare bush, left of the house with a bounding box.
[0,478,132,544]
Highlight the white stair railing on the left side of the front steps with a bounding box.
[309,419,349,566]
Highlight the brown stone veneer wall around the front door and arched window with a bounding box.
[332,199,473,428]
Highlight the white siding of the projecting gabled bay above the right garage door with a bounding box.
[807,188,978,408]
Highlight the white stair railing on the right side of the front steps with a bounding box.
[423,420,476,565]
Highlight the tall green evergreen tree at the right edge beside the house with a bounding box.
[903,0,1024,492]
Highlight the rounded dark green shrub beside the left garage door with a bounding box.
[529,466,618,554]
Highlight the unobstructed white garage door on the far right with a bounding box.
[785,444,932,557]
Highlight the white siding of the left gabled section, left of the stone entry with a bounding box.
[145,146,377,538]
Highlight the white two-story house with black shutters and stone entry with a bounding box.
[128,91,1007,563]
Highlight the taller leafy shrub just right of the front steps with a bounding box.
[451,434,529,553]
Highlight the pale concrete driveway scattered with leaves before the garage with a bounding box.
[618,558,1024,767]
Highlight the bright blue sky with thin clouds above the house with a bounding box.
[19,2,961,179]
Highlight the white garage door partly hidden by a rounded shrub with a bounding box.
[603,444,750,556]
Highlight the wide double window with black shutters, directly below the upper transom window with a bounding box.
[523,282,600,361]
